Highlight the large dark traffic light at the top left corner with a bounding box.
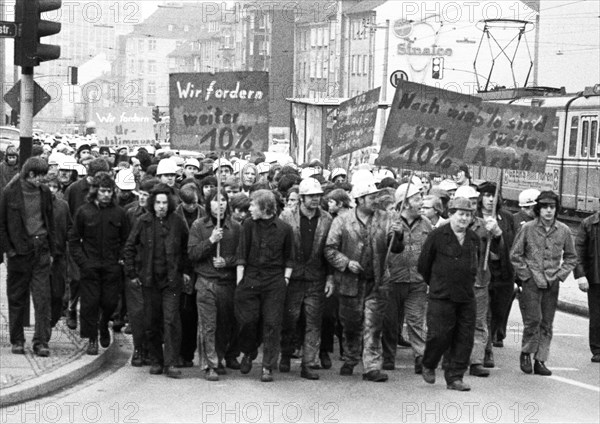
[14,0,62,67]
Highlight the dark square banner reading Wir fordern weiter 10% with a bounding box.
[169,72,269,152]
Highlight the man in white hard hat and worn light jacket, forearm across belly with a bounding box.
[325,171,402,382]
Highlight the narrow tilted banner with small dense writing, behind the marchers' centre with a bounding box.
[331,87,381,158]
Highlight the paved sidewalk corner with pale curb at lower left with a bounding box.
[0,264,119,407]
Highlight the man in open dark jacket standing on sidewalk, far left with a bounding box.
[0,158,56,356]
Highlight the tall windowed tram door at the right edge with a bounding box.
[576,115,600,211]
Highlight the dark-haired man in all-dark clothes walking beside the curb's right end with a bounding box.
[69,172,129,355]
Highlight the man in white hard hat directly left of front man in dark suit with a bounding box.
[383,183,433,374]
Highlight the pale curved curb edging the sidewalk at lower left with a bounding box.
[0,337,122,408]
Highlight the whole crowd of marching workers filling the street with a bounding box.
[0,141,600,391]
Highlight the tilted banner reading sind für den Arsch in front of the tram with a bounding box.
[464,102,557,172]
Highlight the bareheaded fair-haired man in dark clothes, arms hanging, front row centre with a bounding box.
[235,190,295,383]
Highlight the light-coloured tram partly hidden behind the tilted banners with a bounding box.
[470,84,600,217]
